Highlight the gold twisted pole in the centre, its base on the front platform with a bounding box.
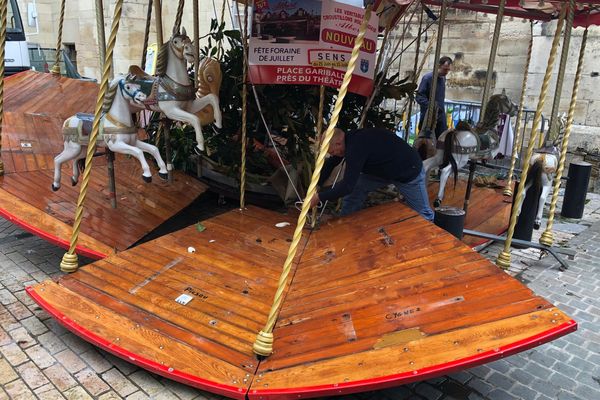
[252,4,373,356]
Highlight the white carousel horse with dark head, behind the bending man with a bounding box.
[423,94,517,207]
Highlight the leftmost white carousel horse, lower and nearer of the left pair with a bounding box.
[52,76,168,191]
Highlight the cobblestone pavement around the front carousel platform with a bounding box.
[0,195,600,400]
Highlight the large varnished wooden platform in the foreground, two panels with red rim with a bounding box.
[27,203,577,399]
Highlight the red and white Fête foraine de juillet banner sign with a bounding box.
[249,0,378,96]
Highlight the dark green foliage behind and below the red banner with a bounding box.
[155,20,415,183]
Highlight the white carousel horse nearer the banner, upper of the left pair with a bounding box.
[127,28,221,151]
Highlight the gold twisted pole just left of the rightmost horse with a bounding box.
[496,9,565,269]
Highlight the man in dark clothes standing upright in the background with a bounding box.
[415,57,452,139]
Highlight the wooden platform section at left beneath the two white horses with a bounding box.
[0,71,206,258]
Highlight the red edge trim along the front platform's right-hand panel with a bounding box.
[248,320,577,400]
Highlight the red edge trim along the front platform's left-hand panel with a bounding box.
[25,286,247,400]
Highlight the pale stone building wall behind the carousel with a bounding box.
[11,0,600,151]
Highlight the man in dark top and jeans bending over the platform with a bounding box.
[311,128,433,221]
